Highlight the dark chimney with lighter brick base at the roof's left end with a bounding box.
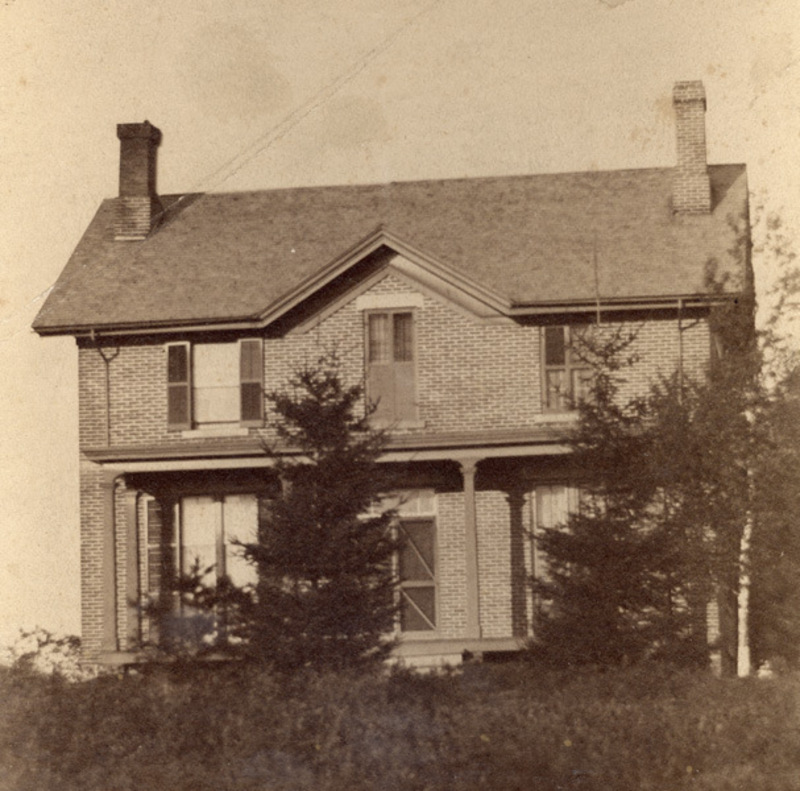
[114,121,161,241]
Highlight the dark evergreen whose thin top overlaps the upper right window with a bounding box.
[534,328,687,665]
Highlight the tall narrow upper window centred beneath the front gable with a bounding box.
[366,311,417,423]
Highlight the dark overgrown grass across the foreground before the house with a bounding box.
[0,665,800,791]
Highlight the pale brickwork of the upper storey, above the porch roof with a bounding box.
[79,275,709,448]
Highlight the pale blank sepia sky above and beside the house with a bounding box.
[0,0,800,643]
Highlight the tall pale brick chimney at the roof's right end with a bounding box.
[672,80,711,214]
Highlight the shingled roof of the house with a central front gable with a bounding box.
[34,165,747,334]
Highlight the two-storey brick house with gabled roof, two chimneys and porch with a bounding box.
[34,82,750,663]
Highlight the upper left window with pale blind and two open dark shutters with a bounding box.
[167,338,264,429]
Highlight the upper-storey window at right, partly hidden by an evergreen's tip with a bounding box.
[542,327,592,412]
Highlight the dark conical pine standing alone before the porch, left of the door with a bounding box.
[236,355,398,670]
